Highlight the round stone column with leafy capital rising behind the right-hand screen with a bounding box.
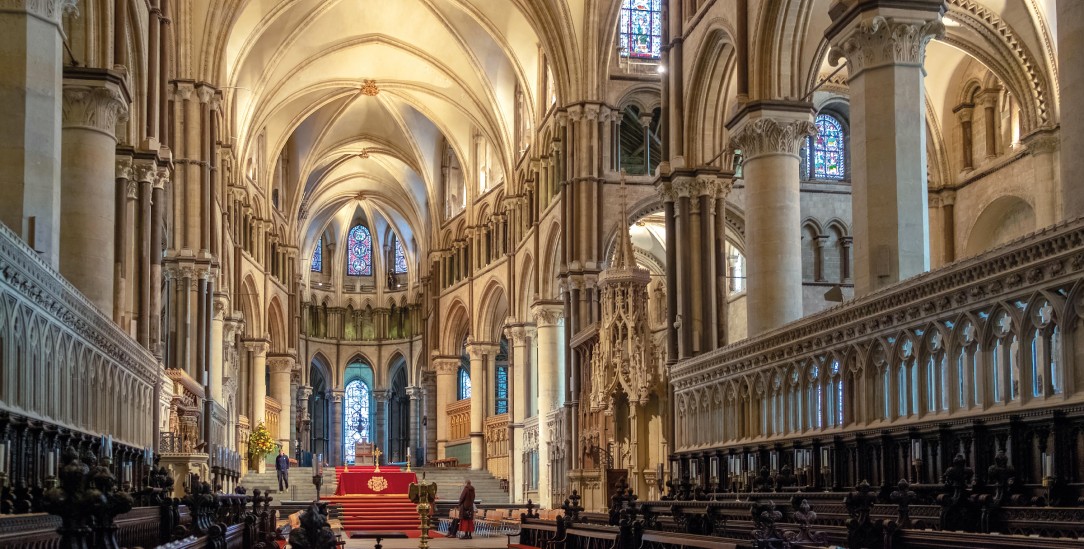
[727,101,815,337]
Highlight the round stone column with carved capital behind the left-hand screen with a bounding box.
[60,67,130,317]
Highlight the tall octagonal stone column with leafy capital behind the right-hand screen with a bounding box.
[823,0,944,292]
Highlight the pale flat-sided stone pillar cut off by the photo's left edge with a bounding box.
[0,0,76,265]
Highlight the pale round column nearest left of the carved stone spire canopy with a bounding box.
[531,303,565,508]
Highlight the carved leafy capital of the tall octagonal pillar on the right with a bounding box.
[828,15,945,79]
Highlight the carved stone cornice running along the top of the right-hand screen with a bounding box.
[671,218,1084,392]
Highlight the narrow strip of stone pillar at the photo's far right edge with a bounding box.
[1057,0,1084,219]
